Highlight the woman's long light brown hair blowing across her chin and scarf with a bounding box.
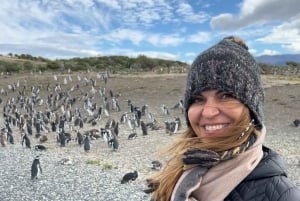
[147,107,254,201]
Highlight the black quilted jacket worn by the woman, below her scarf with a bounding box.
[225,147,300,201]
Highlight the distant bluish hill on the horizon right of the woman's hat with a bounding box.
[255,54,300,65]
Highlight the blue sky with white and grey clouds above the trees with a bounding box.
[0,0,300,63]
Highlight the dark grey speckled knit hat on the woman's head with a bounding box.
[184,36,264,129]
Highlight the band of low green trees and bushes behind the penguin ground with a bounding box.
[0,53,300,76]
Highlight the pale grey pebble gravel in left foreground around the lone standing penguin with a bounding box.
[0,145,149,201]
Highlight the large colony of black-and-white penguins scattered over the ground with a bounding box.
[0,72,183,184]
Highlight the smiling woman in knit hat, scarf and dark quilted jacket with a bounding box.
[145,37,300,201]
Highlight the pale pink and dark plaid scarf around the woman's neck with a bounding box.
[171,127,265,201]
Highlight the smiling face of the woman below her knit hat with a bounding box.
[188,90,245,137]
